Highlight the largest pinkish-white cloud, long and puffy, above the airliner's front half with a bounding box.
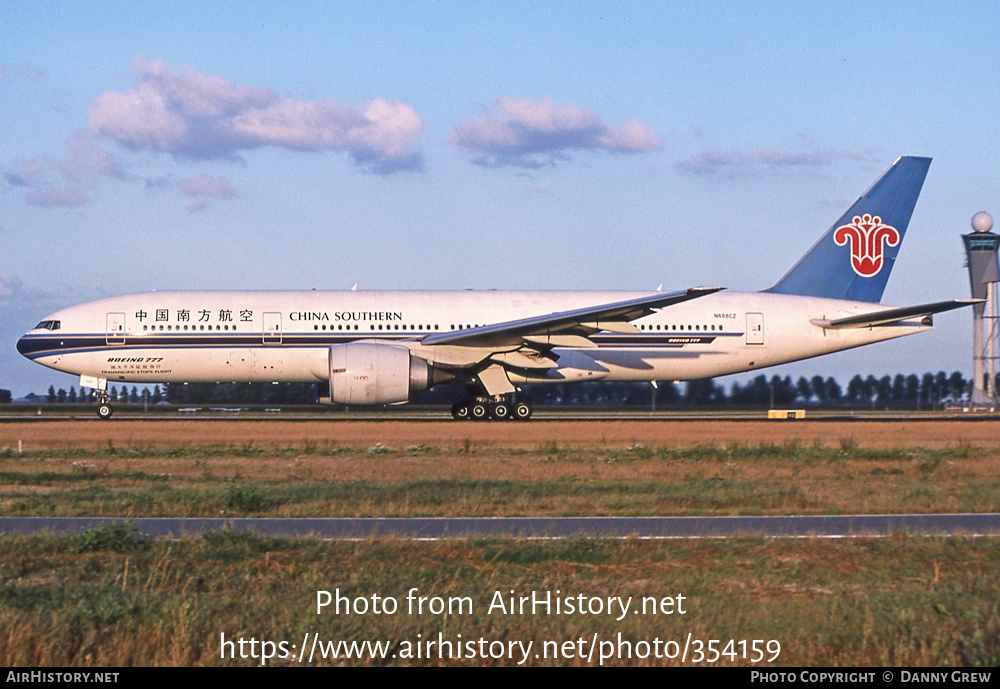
[88,58,424,172]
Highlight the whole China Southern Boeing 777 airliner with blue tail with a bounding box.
[17,157,973,420]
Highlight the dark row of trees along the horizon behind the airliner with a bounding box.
[0,371,980,409]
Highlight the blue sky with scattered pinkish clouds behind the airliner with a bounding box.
[0,0,1000,396]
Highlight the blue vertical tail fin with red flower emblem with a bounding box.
[767,157,931,302]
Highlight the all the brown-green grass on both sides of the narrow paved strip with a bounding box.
[0,420,1000,668]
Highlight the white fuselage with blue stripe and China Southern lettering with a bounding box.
[18,291,931,385]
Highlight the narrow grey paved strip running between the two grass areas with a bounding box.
[0,514,1000,540]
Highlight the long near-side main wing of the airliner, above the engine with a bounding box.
[421,287,722,347]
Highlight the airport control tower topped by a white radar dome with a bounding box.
[962,211,1000,409]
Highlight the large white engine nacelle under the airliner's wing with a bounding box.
[330,342,431,404]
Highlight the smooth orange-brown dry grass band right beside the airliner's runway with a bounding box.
[0,419,1000,451]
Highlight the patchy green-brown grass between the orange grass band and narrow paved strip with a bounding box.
[0,424,1000,517]
